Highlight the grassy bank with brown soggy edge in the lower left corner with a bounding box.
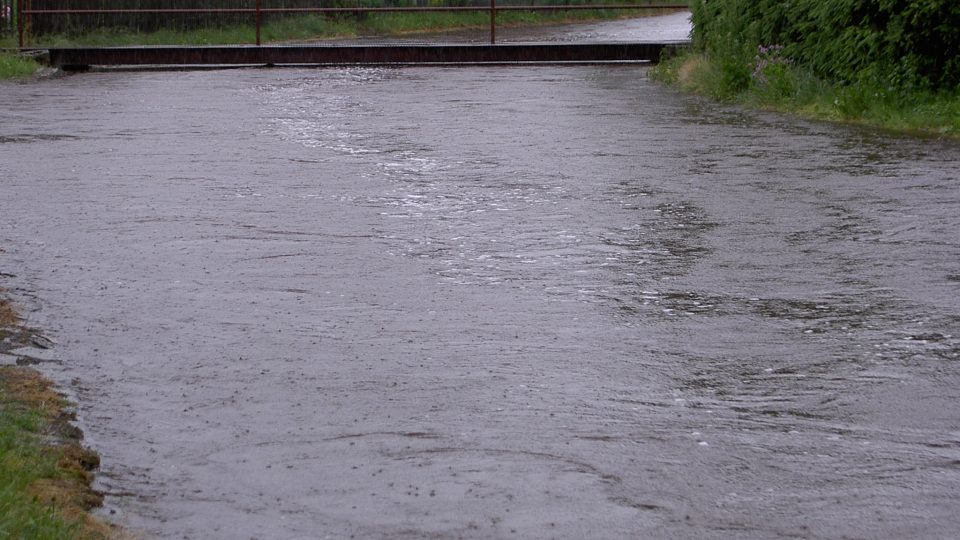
[0,299,117,540]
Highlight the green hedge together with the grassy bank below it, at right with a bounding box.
[654,0,960,138]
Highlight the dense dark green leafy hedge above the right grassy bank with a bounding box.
[691,0,960,90]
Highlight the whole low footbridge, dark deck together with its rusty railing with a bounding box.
[17,0,687,70]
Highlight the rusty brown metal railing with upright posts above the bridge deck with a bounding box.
[16,0,688,49]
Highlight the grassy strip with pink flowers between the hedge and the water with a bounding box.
[653,48,960,139]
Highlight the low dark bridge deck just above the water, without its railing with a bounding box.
[41,42,684,70]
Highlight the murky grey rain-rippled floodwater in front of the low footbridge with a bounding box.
[0,11,960,539]
